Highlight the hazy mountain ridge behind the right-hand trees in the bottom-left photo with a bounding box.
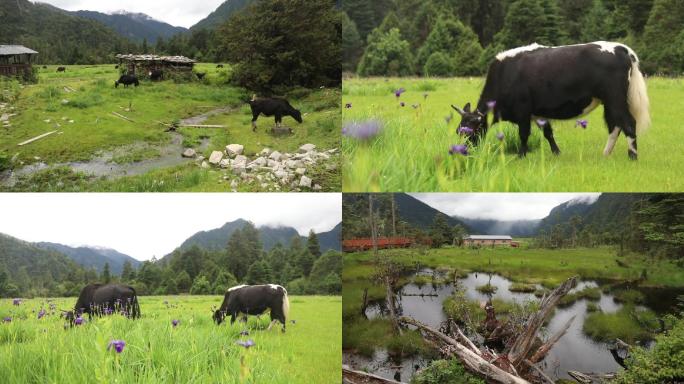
[171,219,342,252]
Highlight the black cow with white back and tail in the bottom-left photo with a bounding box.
[214,284,290,332]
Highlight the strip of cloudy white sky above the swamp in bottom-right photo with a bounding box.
[410,193,600,220]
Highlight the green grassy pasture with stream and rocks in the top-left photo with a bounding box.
[0,63,341,192]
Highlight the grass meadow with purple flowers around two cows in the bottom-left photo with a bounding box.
[0,296,342,384]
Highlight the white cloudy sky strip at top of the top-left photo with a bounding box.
[33,0,225,28]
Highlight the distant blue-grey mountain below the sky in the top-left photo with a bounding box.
[72,11,187,44]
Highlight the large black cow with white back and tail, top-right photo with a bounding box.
[452,41,650,160]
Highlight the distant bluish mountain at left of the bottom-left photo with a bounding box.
[35,242,140,275]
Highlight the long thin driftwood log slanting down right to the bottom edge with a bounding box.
[399,317,530,384]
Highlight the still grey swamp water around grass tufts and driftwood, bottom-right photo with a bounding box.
[358,269,684,381]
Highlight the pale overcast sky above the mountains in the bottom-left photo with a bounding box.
[0,193,342,260]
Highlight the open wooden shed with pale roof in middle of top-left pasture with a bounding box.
[116,54,196,79]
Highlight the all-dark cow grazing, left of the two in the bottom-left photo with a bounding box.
[65,284,140,326]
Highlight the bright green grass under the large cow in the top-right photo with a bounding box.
[342,77,684,192]
